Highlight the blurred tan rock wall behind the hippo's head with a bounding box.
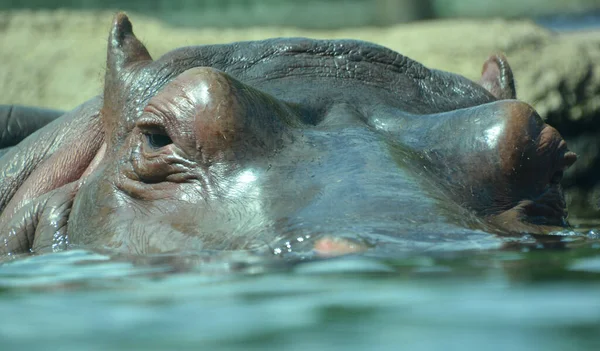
[0,11,600,217]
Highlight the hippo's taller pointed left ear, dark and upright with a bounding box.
[107,12,152,77]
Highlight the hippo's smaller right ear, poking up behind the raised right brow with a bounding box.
[479,54,517,100]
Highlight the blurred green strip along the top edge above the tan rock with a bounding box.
[0,0,600,29]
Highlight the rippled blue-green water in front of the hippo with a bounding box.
[0,227,600,351]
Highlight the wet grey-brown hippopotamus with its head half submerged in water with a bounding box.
[0,13,576,256]
